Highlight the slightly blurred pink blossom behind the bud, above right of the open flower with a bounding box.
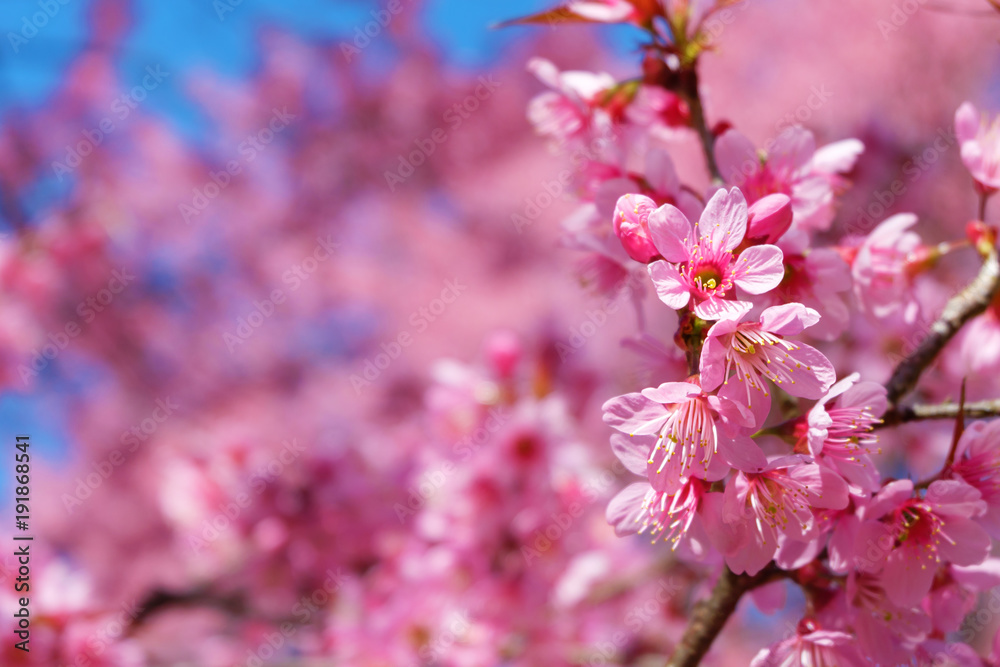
[715,126,864,231]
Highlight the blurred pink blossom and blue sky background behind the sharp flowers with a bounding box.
[0,0,1000,667]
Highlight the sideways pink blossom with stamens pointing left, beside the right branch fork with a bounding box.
[806,373,886,495]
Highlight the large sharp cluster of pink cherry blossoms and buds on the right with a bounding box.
[530,2,1000,666]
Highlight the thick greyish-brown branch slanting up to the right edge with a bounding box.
[885,247,1000,409]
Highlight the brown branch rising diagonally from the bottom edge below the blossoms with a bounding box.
[667,562,786,667]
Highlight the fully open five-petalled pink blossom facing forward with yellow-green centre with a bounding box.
[648,188,784,320]
